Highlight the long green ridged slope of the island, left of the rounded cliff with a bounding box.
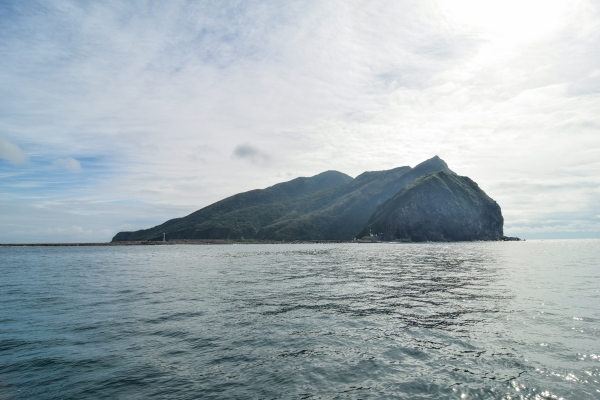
[113,156,452,241]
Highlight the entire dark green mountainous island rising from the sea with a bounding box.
[112,156,510,242]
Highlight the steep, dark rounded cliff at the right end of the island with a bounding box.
[361,171,504,242]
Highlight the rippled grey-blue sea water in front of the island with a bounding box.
[0,240,600,399]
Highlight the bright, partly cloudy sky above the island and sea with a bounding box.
[0,0,600,243]
